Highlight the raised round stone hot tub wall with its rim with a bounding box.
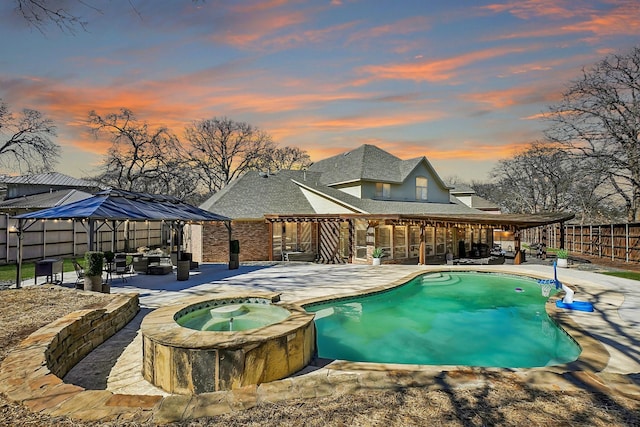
[140,293,315,394]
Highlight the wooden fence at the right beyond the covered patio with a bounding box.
[522,223,640,263]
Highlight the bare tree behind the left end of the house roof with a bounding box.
[185,117,275,192]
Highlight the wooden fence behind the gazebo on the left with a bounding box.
[0,215,172,264]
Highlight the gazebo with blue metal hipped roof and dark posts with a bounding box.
[14,189,231,288]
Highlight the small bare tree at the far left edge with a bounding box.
[0,99,60,173]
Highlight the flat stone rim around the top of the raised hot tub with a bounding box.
[140,292,314,349]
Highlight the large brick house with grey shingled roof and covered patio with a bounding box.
[201,145,571,263]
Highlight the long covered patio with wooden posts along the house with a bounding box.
[265,213,574,264]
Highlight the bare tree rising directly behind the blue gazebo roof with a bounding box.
[89,108,197,199]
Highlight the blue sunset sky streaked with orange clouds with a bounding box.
[0,0,640,182]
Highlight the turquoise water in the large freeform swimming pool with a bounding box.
[306,272,581,368]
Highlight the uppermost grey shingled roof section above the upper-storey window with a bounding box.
[309,144,447,188]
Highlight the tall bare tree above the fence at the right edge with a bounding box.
[546,47,640,221]
